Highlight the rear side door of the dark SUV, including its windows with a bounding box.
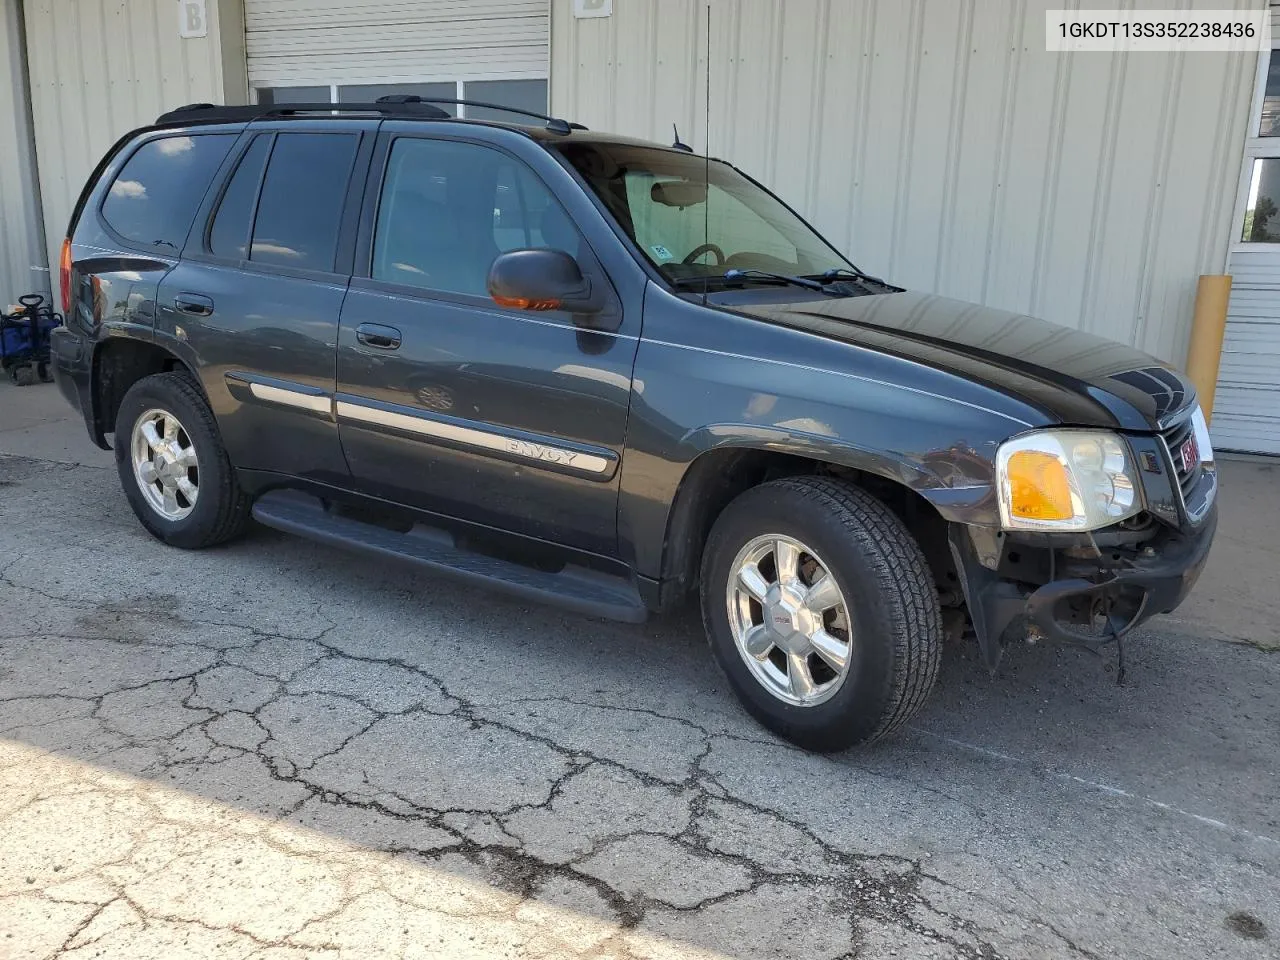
[156,119,376,484]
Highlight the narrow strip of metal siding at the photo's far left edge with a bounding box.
[0,0,50,302]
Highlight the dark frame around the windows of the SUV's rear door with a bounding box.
[183,119,380,283]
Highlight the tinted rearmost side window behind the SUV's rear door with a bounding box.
[102,133,236,251]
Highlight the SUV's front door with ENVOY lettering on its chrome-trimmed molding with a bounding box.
[335,131,640,556]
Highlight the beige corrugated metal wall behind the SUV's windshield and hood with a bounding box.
[550,0,1263,364]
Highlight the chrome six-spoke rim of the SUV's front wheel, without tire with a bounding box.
[726,534,852,707]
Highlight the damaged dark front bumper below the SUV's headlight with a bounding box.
[948,504,1217,668]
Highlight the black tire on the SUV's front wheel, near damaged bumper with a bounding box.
[701,476,943,753]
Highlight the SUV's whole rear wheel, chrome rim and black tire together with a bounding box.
[115,372,250,549]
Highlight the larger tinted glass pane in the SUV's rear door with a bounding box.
[248,133,357,270]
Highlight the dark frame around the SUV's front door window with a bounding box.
[351,129,622,325]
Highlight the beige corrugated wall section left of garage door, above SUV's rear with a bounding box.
[26,0,243,277]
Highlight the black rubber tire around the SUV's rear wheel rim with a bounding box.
[114,372,251,549]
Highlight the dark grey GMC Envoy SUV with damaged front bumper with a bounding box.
[54,99,1217,750]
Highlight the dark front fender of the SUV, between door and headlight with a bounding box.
[618,289,1037,579]
